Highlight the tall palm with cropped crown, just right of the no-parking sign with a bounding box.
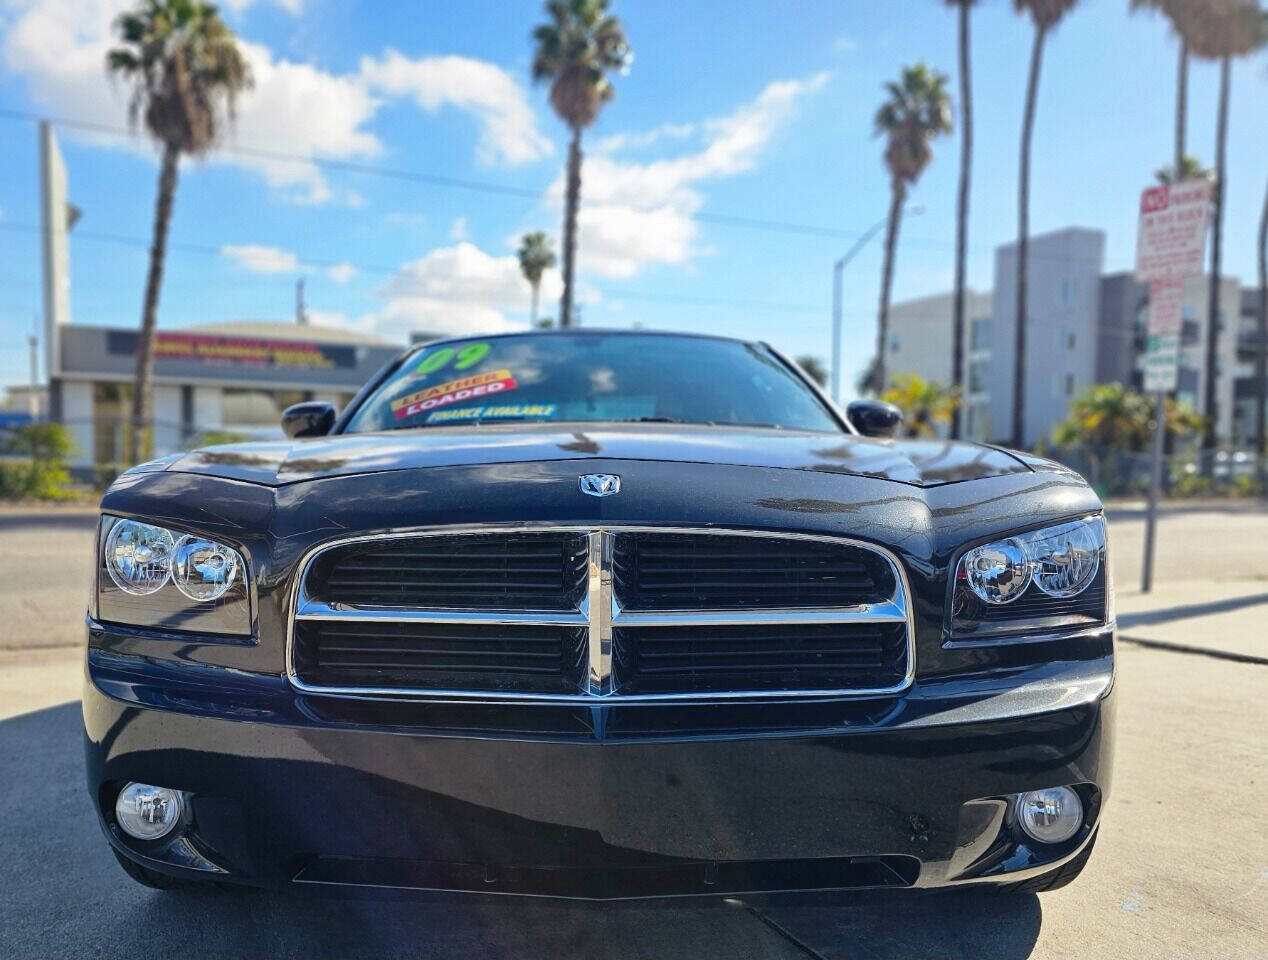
[1168,0,1265,472]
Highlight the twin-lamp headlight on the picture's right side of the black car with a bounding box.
[951,516,1108,639]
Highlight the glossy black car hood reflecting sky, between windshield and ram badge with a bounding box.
[143,424,1031,487]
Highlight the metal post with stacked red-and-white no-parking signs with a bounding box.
[1136,180,1215,594]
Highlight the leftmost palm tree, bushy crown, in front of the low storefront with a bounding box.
[105,0,251,463]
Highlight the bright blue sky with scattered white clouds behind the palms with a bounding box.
[0,0,1268,393]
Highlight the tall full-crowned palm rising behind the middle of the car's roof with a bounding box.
[533,0,633,327]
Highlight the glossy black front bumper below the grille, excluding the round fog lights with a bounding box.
[84,628,1113,899]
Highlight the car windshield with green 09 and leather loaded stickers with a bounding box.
[346,334,841,432]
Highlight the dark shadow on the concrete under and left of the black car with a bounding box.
[0,703,1042,960]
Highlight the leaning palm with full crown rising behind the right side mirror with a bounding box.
[875,63,951,389]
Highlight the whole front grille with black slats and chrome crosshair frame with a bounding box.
[288,528,914,703]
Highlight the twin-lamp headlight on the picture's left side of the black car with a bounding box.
[96,516,251,635]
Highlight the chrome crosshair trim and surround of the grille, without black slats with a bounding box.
[285,524,915,706]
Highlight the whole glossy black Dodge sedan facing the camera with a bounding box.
[84,330,1115,900]
